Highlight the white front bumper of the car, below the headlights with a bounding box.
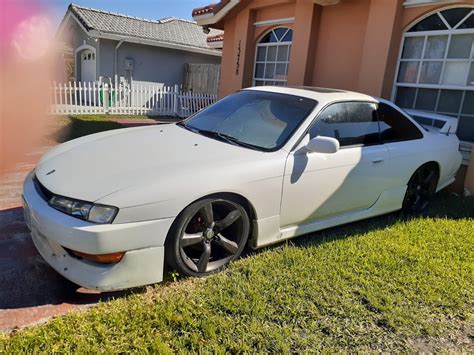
[23,173,173,291]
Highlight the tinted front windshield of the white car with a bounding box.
[181,90,318,151]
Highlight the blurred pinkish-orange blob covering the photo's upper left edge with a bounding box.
[0,0,56,176]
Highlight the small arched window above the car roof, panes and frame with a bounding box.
[253,27,293,86]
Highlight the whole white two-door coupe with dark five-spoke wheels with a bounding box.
[24,87,461,290]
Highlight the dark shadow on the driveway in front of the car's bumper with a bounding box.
[0,207,143,310]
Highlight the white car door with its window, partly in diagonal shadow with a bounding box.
[280,102,389,228]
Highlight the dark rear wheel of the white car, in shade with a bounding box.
[402,165,439,214]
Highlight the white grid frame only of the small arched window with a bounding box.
[252,26,294,86]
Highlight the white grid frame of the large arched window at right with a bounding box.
[391,4,474,144]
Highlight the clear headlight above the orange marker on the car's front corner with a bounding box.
[49,196,118,224]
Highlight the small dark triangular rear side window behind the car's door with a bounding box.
[377,102,423,143]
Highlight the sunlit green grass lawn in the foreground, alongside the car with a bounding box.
[0,193,474,353]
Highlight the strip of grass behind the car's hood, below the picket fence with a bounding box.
[52,115,176,143]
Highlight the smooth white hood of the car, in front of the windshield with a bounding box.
[35,124,265,202]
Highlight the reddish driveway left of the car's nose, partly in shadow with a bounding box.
[0,146,131,332]
